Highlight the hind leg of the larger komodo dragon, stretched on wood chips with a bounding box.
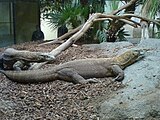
[57,68,98,84]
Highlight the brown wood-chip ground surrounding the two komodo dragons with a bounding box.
[0,42,123,120]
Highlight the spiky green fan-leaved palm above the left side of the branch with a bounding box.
[43,4,88,28]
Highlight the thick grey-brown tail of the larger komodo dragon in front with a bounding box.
[0,69,57,84]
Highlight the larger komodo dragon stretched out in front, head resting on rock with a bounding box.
[0,50,143,83]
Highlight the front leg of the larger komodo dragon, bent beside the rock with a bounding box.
[111,65,124,82]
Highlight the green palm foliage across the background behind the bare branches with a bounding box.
[41,0,160,42]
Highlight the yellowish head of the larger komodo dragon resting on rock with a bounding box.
[114,50,144,69]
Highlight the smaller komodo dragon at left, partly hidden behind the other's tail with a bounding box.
[0,48,55,70]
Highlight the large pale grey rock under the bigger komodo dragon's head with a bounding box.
[96,39,160,120]
